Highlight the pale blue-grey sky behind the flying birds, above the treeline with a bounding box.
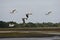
[0,0,60,23]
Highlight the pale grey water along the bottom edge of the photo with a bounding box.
[0,36,60,40]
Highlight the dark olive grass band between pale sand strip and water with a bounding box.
[0,33,58,38]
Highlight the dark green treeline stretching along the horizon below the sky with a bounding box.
[0,21,60,28]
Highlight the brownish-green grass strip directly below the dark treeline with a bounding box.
[0,27,60,32]
